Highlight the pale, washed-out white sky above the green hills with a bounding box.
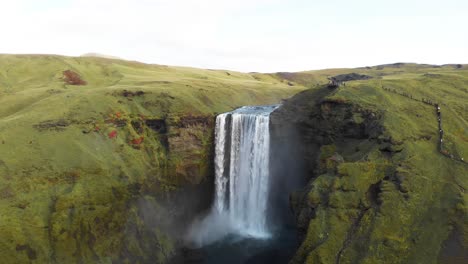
[0,0,468,72]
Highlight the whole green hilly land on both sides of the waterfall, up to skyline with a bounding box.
[0,55,468,263]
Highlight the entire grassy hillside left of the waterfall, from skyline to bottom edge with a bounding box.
[0,55,304,263]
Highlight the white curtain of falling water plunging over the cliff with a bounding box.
[213,105,278,238]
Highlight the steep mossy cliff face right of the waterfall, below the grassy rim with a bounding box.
[272,87,468,263]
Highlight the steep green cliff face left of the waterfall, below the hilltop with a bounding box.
[1,109,213,263]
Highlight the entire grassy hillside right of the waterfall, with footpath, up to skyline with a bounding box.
[277,64,468,263]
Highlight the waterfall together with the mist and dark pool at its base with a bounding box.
[187,105,306,263]
